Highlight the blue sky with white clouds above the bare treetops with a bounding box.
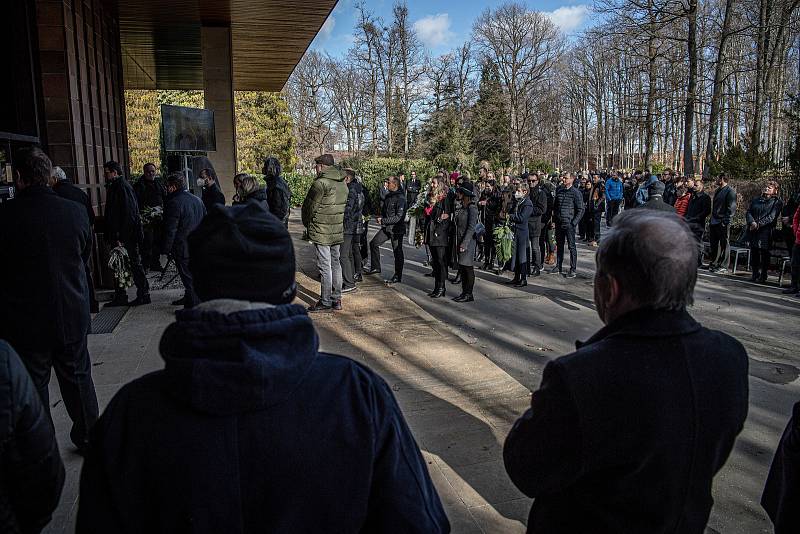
[312,0,591,56]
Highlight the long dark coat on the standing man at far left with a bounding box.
[0,186,92,350]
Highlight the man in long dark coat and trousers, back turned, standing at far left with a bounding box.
[0,148,98,451]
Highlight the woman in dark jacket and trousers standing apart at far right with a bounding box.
[745,180,783,284]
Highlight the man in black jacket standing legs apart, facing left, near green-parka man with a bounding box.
[365,176,406,284]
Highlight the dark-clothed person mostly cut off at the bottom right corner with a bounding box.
[761,402,800,534]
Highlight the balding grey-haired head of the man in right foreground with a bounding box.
[595,209,698,322]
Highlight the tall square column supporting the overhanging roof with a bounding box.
[200,26,237,203]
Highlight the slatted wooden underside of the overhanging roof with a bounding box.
[116,0,337,91]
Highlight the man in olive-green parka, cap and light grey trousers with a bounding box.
[303,154,348,312]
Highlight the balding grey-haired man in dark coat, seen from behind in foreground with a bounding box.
[503,210,748,533]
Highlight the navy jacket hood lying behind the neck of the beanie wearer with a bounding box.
[159,300,319,415]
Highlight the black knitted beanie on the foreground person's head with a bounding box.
[189,202,297,304]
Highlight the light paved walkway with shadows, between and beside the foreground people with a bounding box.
[45,227,530,533]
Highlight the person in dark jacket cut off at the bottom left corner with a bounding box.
[0,340,64,534]
